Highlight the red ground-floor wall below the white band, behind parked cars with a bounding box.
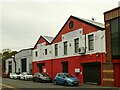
[32,53,106,83]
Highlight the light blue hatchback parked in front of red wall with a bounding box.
[54,73,79,86]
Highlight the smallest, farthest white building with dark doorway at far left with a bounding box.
[5,57,15,74]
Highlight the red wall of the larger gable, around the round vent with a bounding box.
[53,18,97,43]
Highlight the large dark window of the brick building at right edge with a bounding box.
[110,18,120,59]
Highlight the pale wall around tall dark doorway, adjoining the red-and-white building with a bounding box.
[15,50,32,73]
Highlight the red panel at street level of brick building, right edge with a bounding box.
[114,63,120,87]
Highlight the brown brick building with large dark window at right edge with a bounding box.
[103,6,120,87]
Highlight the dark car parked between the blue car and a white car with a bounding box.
[33,72,52,82]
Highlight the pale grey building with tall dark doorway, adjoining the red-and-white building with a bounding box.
[15,48,32,73]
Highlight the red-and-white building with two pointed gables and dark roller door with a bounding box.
[32,16,106,85]
